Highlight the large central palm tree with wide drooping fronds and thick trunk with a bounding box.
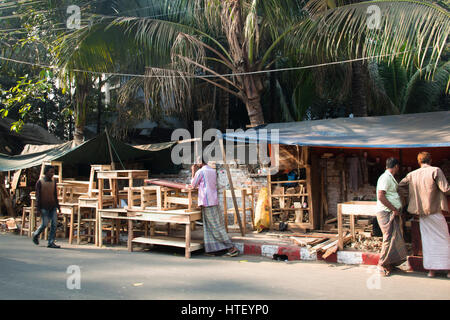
[60,0,450,125]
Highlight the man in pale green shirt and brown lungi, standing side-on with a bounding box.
[377,158,407,276]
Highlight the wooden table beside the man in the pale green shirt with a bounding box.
[337,201,378,250]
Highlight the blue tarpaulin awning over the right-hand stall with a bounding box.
[224,111,450,148]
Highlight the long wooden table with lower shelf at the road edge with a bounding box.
[98,208,203,258]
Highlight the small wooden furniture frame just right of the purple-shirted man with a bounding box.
[222,186,256,233]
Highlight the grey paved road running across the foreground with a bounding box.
[0,234,450,300]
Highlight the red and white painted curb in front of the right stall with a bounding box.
[234,242,380,265]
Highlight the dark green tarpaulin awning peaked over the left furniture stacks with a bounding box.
[0,133,174,171]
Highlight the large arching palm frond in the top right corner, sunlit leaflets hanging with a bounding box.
[295,0,450,75]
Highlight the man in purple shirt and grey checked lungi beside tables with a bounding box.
[191,163,239,257]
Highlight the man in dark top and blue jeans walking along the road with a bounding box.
[33,166,61,248]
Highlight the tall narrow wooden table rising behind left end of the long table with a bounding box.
[96,170,148,246]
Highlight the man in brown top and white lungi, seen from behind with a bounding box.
[399,152,450,278]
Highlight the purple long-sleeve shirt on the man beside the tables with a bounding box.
[191,165,219,207]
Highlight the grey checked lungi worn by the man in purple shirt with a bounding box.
[202,206,234,252]
